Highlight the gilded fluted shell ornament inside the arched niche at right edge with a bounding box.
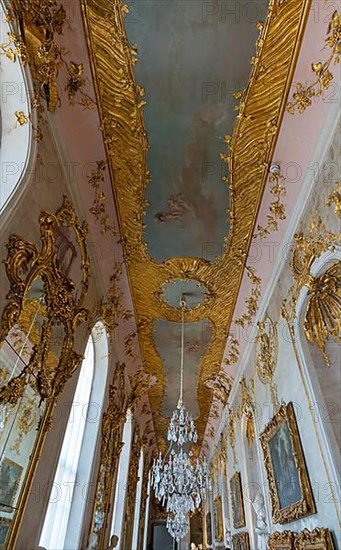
[304,262,341,367]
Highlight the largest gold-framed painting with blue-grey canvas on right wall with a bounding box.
[260,403,316,523]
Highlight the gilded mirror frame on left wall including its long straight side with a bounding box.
[0,196,90,548]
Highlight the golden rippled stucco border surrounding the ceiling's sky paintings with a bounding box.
[82,0,310,443]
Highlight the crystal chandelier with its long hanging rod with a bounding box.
[152,298,209,541]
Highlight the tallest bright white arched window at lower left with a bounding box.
[40,322,108,550]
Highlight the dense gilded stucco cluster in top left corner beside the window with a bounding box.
[7,0,95,142]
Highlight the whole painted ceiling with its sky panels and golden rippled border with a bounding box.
[82,0,309,449]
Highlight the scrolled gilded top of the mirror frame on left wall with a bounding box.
[0,196,90,404]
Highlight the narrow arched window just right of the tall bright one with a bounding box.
[110,410,133,545]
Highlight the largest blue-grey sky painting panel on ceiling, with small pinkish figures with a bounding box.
[125,0,268,261]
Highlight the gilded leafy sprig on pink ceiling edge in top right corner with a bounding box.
[287,10,341,115]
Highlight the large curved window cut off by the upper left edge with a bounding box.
[0,0,33,213]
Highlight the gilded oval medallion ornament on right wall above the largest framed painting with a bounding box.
[256,316,280,410]
